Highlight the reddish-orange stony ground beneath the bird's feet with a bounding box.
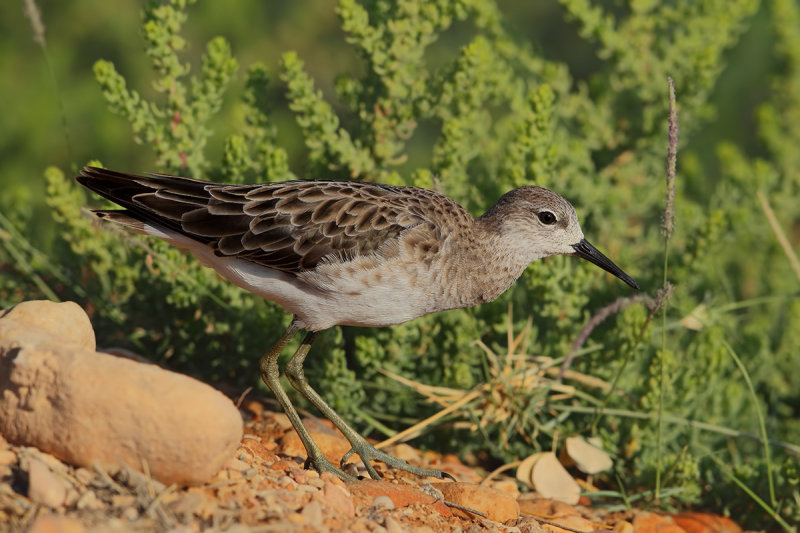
[0,401,752,533]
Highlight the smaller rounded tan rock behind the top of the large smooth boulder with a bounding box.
[0,300,96,351]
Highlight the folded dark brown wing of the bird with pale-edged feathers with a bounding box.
[76,167,462,272]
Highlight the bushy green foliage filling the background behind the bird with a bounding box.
[0,0,800,524]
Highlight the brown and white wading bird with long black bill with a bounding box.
[76,167,639,480]
